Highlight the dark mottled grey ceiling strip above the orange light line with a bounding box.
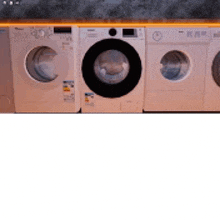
[0,0,220,20]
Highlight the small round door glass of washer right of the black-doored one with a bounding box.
[160,51,190,81]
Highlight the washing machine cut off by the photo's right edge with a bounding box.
[204,28,220,111]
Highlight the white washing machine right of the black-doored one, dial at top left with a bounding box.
[144,27,210,112]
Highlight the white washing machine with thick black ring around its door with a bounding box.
[79,27,145,113]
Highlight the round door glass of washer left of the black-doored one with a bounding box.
[26,47,58,82]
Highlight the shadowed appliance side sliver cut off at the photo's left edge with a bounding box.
[0,27,15,113]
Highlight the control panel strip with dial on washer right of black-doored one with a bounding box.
[146,28,211,44]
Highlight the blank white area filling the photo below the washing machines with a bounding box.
[0,114,220,220]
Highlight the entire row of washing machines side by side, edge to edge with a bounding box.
[0,25,220,112]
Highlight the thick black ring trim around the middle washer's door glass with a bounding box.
[82,38,142,98]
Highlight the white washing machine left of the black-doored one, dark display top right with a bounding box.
[10,25,80,113]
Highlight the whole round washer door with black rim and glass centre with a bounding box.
[82,39,142,98]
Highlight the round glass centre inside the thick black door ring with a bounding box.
[94,50,130,84]
